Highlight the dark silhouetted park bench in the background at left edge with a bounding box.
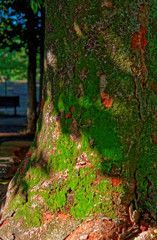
[0,96,20,115]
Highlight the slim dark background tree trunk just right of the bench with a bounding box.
[27,8,37,132]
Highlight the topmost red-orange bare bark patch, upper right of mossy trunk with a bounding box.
[130,25,148,51]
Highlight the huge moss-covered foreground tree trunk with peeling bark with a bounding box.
[0,0,157,240]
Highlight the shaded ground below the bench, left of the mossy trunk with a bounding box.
[0,115,34,219]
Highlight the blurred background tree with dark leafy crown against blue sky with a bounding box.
[0,0,44,131]
